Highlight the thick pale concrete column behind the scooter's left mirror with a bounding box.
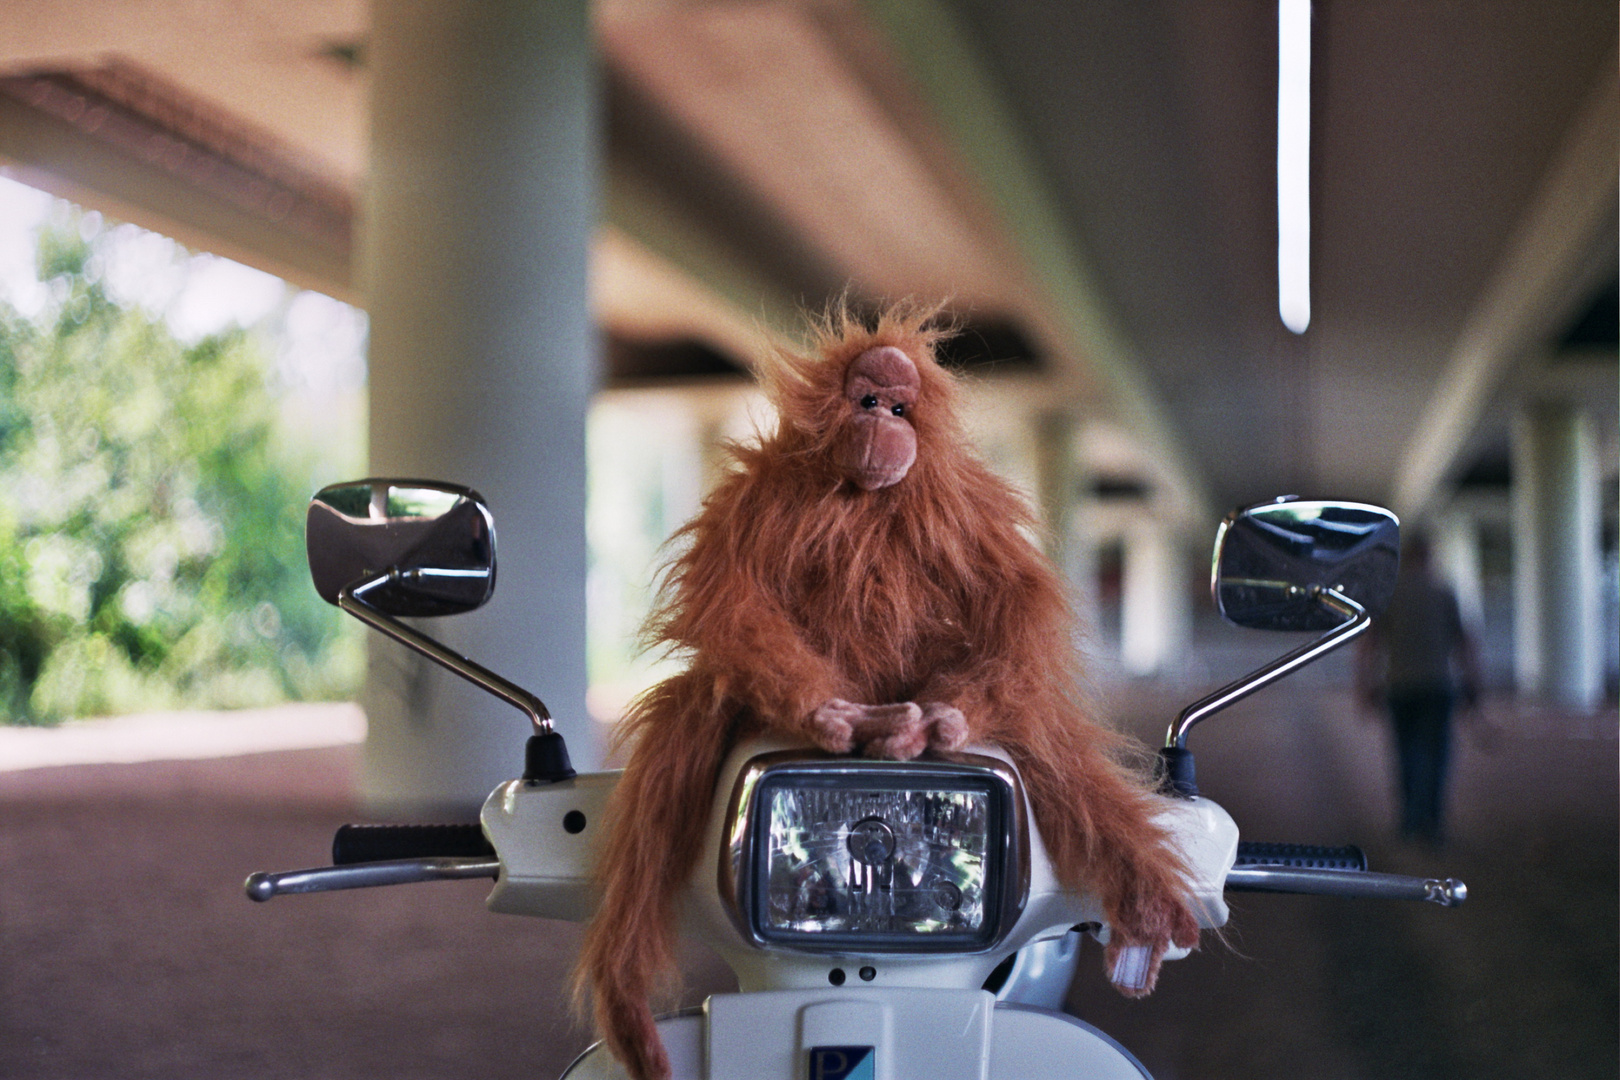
[360,0,599,813]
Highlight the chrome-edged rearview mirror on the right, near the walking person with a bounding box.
[1213,497,1401,630]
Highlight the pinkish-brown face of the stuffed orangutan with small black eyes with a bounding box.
[838,345,922,491]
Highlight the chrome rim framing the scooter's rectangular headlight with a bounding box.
[719,748,1030,955]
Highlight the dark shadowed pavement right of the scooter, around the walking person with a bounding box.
[1069,687,1620,1080]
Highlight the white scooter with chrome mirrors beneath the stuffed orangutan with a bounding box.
[246,479,1466,1080]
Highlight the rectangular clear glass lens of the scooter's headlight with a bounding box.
[752,769,1008,949]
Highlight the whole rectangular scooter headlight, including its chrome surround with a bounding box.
[721,753,1027,952]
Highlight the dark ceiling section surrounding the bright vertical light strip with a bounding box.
[966,0,1615,514]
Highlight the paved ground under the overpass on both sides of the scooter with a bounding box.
[0,685,1620,1080]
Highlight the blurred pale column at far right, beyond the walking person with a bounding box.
[1513,402,1604,708]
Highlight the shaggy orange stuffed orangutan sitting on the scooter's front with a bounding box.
[578,309,1199,1080]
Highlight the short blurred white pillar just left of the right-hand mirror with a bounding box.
[1119,520,1192,675]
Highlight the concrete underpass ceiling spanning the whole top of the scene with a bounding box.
[0,0,1617,524]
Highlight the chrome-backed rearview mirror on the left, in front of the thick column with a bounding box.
[306,479,496,617]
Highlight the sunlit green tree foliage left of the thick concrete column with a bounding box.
[0,213,361,724]
